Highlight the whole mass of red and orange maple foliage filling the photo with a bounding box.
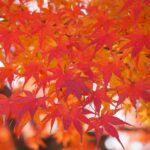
[0,0,150,147]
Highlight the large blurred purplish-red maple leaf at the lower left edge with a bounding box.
[0,91,46,125]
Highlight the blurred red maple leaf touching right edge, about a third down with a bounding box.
[121,34,150,57]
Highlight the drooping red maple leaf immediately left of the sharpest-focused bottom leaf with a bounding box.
[43,104,89,140]
